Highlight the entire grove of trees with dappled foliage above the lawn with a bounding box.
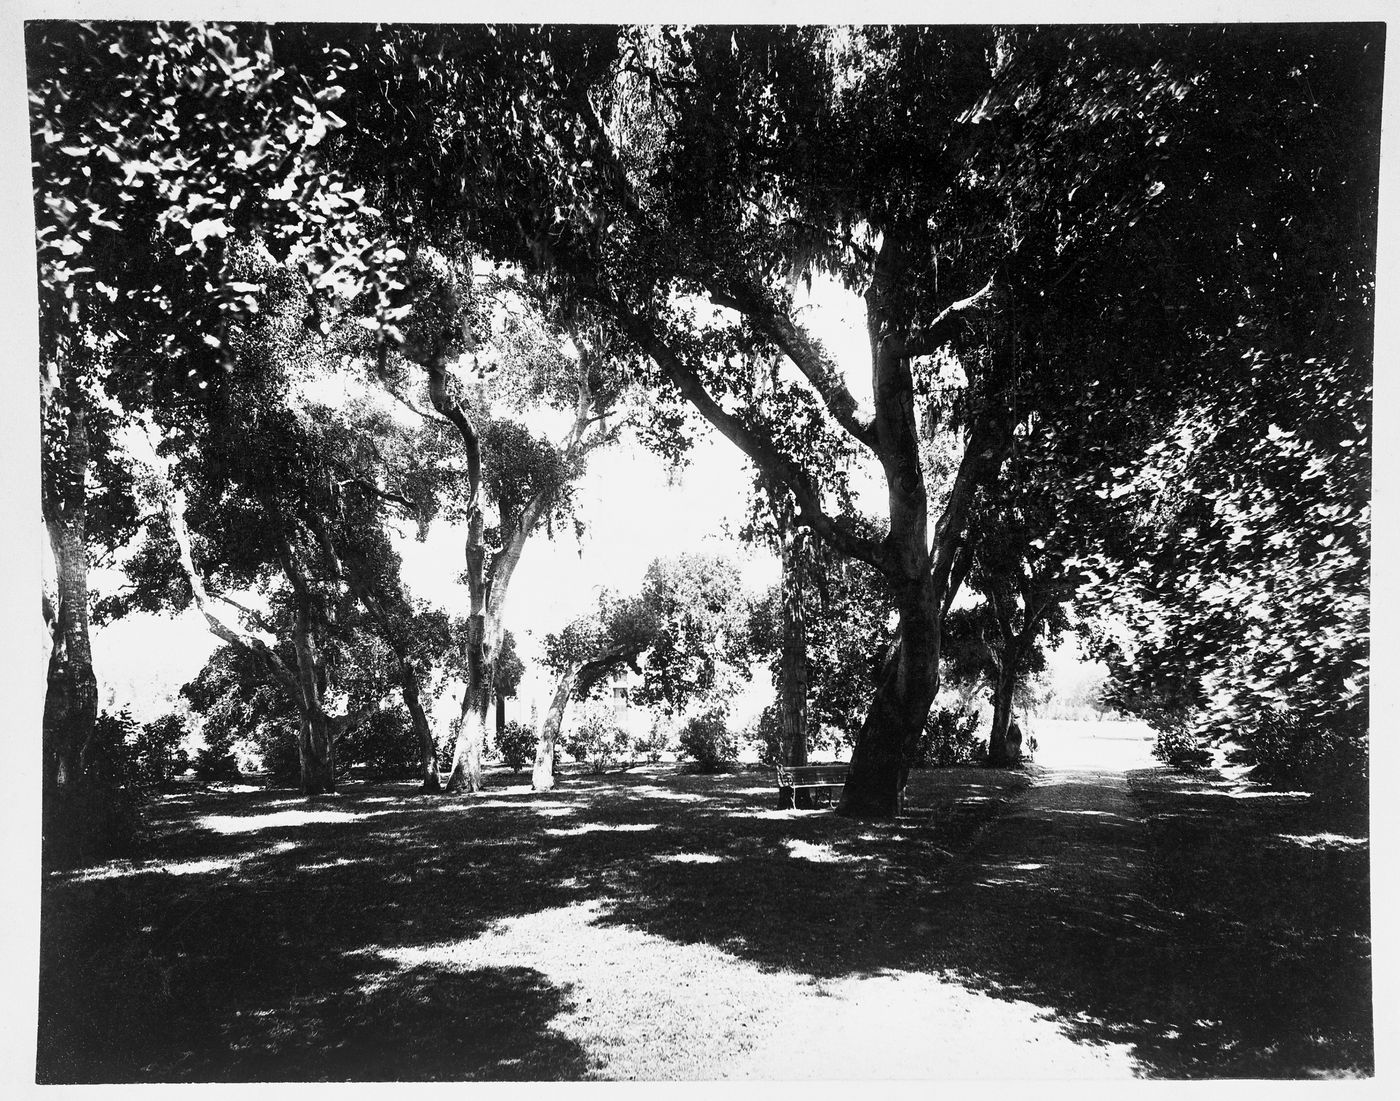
[27,22,1383,853]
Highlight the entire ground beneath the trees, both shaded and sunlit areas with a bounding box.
[39,739,1371,1081]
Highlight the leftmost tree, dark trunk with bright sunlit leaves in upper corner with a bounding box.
[25,21,389,851]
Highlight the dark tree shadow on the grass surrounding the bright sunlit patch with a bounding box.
[39,770,1371,1081]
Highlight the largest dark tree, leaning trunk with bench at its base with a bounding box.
[301,27,1372,817]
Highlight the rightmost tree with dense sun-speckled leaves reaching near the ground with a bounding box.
[1080,27,1382,791]
